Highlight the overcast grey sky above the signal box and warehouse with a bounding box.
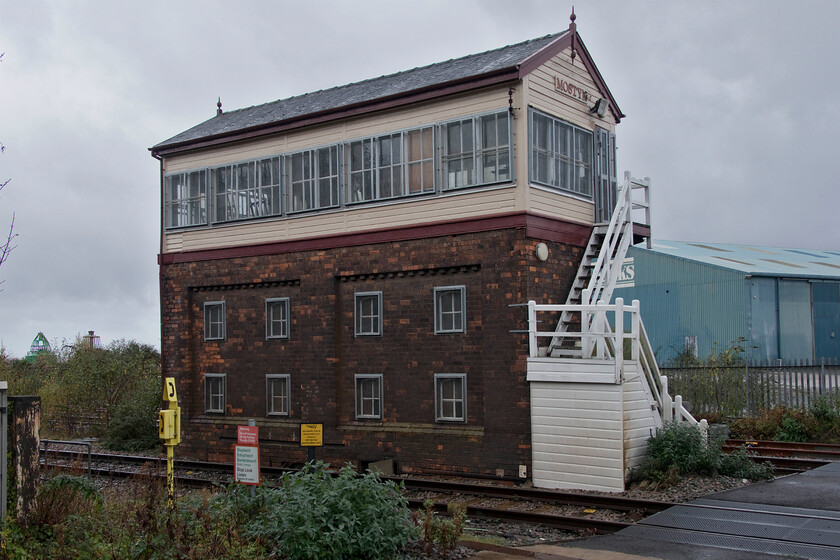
[0,0,840,357]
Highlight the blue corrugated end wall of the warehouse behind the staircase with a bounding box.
[613,247,749,364]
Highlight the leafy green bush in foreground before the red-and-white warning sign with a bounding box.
[232,463,416,560]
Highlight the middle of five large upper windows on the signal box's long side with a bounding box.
[286,146,339,212]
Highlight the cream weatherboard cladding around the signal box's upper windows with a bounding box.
[163,43,614,253]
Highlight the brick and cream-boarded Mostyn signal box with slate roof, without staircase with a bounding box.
[151,18,688,490]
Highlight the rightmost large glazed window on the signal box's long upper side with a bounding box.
[441,111,511,189]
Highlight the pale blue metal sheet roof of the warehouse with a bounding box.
[633,240,840,280]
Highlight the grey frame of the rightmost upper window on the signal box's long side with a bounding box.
[438,109,514,191]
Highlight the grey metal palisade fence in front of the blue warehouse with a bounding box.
[660,360,840,417]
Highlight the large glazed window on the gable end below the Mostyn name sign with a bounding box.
[530,110,593,197]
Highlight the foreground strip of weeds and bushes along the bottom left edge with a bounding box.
[0,463,419,560]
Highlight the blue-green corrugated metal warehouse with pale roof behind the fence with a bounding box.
[614,241,840,364]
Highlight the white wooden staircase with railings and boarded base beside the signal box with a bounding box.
[527,173,706,491]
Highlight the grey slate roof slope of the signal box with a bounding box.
[151,29,572,153]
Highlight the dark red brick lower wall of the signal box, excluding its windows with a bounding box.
[161,222,582,477]
